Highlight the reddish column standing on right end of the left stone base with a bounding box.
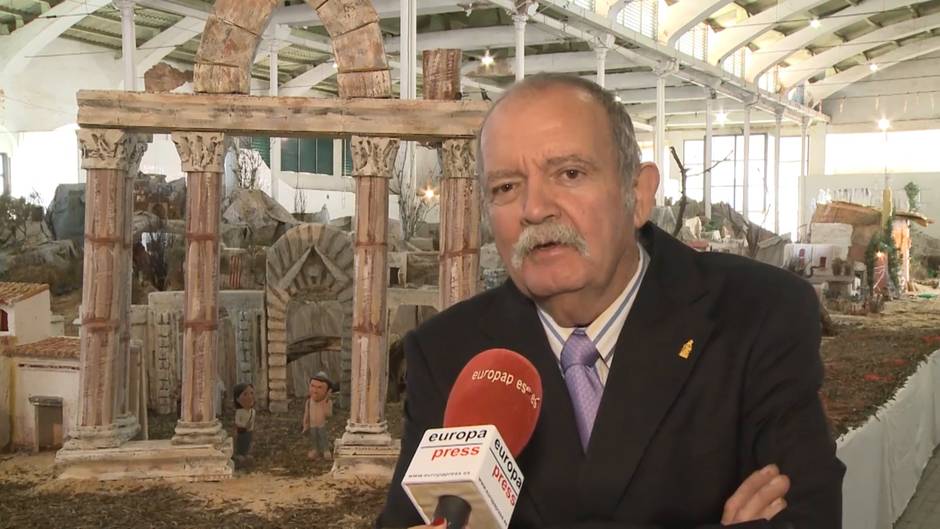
[173,132,228,445]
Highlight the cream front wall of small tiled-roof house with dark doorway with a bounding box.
[13,357,79,447]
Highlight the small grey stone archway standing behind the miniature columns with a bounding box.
[259,224,354,412]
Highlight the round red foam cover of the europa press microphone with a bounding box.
[444,349,542,457]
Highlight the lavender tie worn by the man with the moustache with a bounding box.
[561,328,604,452]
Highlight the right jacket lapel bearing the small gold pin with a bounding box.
[569,226,718,519]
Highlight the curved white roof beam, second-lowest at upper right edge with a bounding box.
[778,13,940,90]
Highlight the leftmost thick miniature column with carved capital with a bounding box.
[64,129,150,450]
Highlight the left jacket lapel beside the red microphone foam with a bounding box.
[481,281,584,522]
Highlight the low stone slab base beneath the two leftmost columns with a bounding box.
[54,439,234,481]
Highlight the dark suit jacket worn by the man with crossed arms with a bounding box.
[377,224,845,529]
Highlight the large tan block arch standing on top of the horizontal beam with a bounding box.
[193,0,392,98]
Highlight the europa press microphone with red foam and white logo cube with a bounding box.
[402,349,542,529]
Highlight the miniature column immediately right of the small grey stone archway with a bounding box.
[338,136,398,442]
